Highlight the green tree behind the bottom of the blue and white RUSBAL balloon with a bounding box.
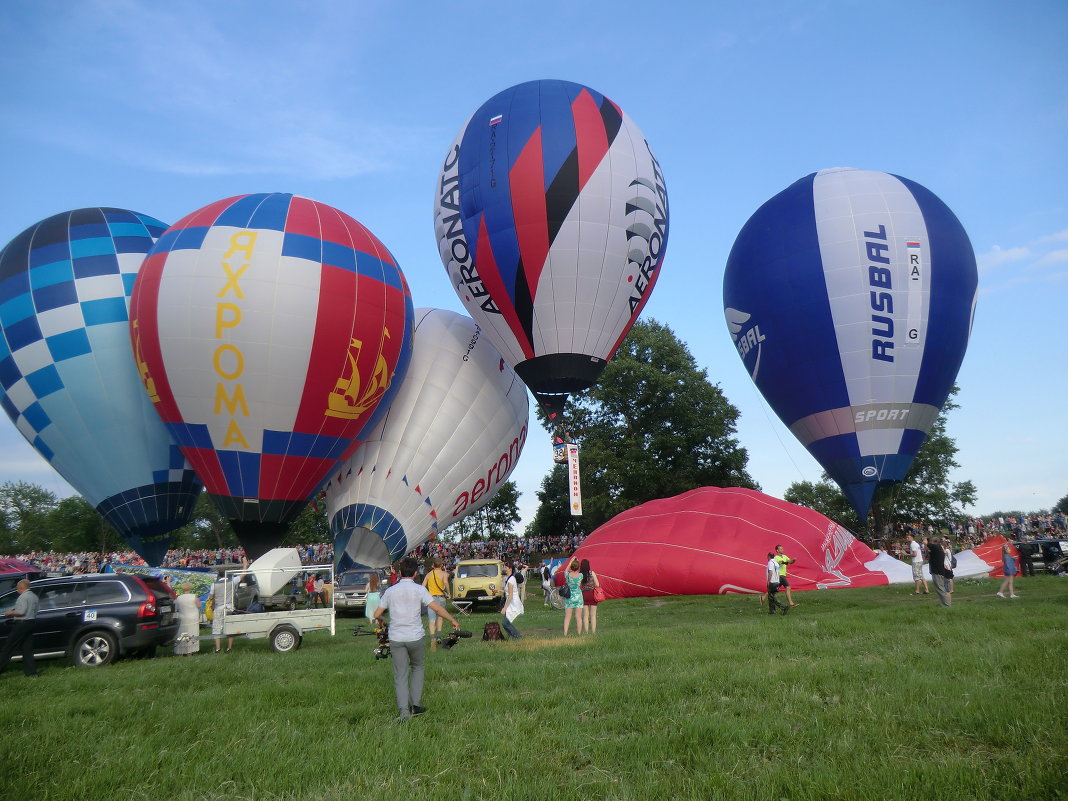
[783,387,976,539]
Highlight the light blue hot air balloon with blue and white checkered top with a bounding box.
[0,208,201,565]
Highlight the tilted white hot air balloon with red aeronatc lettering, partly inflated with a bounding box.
[326,309,529,570]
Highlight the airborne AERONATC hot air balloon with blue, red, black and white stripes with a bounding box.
[435,80,668,419]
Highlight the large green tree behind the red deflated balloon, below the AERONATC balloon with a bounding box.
[531,320,757,530]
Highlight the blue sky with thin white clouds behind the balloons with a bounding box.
[0,0,1068,534]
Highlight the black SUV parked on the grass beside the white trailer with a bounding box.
[0,574,178,668]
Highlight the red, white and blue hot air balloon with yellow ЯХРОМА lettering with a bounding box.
[130,193,412,559]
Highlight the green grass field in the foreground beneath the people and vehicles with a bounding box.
[0,576,1068,801]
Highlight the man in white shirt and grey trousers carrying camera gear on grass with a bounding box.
[375,559,460,721]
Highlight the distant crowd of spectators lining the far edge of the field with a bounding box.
[6,521,1068,575]
